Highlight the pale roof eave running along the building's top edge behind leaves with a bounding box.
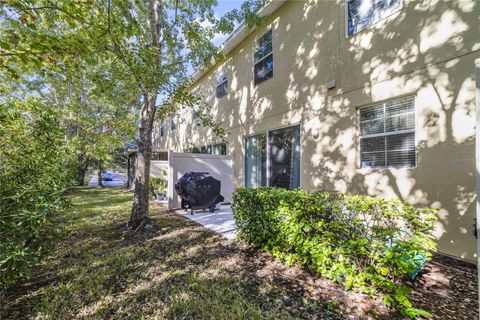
[191,0,287,84]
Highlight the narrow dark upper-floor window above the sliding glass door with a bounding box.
[253,29,273,85]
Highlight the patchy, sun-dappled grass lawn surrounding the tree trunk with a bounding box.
[0,188,341,319]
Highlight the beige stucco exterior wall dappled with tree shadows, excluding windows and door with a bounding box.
[155,0,480,260]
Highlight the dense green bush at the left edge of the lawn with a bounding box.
[0,99,69,291]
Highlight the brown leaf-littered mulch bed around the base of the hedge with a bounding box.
[171,209,479,320]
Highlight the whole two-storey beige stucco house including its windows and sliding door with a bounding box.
[154,0,480,260]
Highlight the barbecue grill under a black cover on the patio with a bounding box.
[175,172,224,214]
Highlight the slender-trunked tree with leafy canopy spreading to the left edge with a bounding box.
[0,0,266,229]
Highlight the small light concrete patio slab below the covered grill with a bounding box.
[175,205,237,239]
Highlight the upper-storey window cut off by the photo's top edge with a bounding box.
[346,0,403,36]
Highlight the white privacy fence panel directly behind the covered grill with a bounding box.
[166,151,234,210]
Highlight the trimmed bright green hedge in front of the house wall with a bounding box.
[232,188,437,317]
